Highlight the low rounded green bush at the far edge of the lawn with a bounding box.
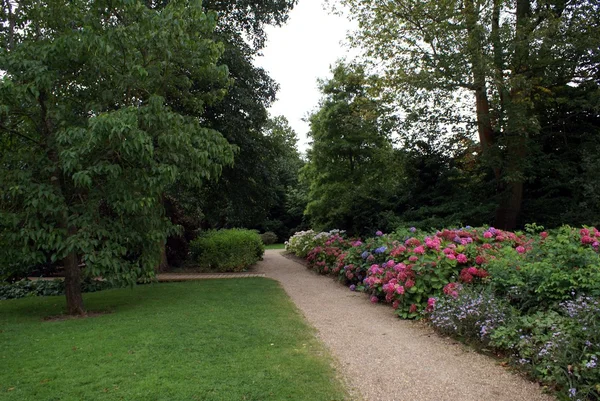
[190,229,265,272]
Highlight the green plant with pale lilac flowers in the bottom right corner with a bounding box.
[491,297,600,400]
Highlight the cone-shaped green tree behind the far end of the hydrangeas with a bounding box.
[303,63,402,234]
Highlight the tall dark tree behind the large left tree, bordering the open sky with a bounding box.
[192,0,297,229]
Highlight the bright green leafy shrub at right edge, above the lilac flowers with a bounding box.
[488,226,600,311]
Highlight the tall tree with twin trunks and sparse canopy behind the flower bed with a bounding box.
[343,0,600,228]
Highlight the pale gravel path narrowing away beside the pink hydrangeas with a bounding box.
[257,250,554,401]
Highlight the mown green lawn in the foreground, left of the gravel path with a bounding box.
[0,278,347,401]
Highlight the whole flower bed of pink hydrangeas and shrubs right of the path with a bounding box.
[288,225,600,401]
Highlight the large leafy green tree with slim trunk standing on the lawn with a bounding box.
[0,0,233,314]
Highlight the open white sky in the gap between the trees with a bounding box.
[255,0,354,152]
